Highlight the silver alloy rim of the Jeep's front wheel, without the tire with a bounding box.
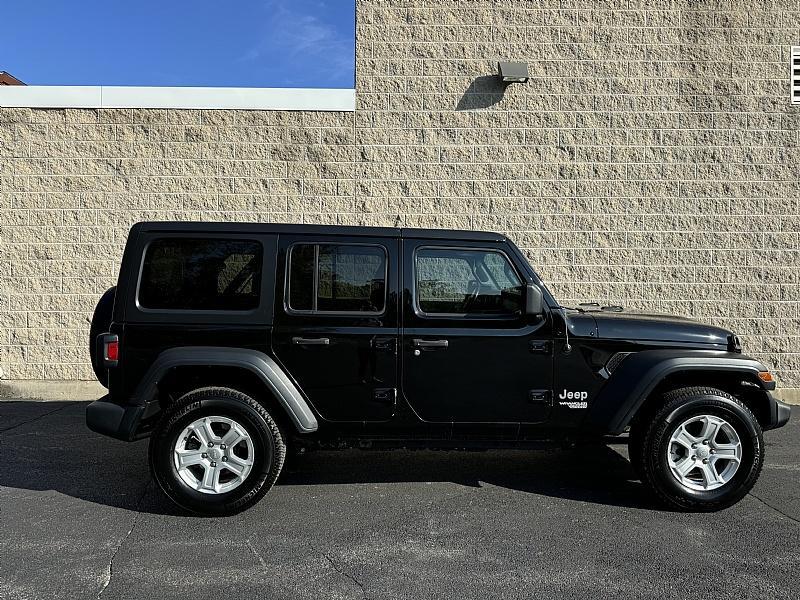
[667,415,742,491]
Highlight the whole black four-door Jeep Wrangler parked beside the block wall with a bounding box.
[86,223,790,514]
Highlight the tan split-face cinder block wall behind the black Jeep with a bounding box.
[0,0,800,388]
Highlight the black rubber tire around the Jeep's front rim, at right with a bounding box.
[631,387,764,512]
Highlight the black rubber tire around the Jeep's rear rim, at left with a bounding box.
[149,387,286,516]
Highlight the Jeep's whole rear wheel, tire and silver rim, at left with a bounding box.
[150,387,286,515]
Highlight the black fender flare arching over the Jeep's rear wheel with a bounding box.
[130,346,319,433]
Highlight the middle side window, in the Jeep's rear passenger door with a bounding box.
[287,244,386,314]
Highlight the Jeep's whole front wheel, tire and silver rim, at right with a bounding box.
[631,387,764,511]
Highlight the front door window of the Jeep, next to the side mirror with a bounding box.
[415,248,524,316]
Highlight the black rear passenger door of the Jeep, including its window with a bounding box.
[272,236,399,421]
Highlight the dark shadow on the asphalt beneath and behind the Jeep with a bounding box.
[0,401,658,515]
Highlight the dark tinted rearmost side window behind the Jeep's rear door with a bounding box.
[138,238,263,311]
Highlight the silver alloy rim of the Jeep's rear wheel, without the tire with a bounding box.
[173,416,254,494]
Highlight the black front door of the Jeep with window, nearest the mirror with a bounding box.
[401,239,553,430]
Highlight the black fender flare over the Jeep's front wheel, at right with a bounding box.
[584,349,774,435]
